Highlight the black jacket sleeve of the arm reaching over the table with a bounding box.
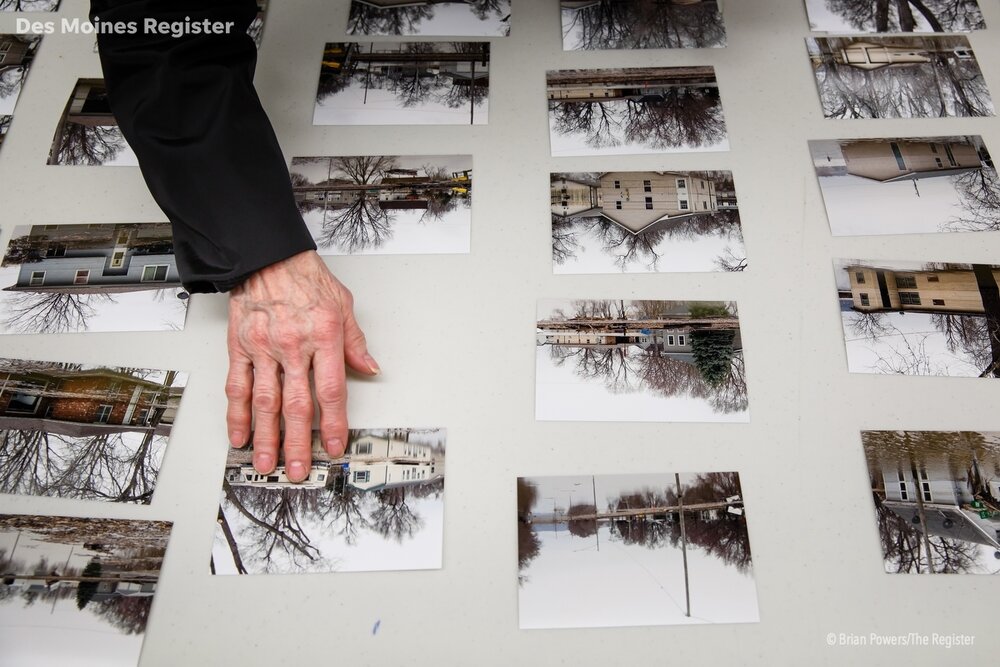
[91,0,316,292]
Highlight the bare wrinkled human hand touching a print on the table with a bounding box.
[226,250,379,482]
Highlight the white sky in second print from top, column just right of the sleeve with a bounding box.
[313,81,489,125]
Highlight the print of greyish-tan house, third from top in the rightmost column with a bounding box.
[809,136,1000,236]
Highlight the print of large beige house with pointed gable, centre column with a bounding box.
[549,171,747,273]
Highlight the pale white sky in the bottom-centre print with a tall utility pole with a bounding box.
[518,523,759,629]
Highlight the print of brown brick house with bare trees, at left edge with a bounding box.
[0,358,187,505]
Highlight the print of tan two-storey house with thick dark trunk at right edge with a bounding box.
[834,259,1000,378]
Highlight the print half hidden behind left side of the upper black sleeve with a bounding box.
[48,79,139,167]
